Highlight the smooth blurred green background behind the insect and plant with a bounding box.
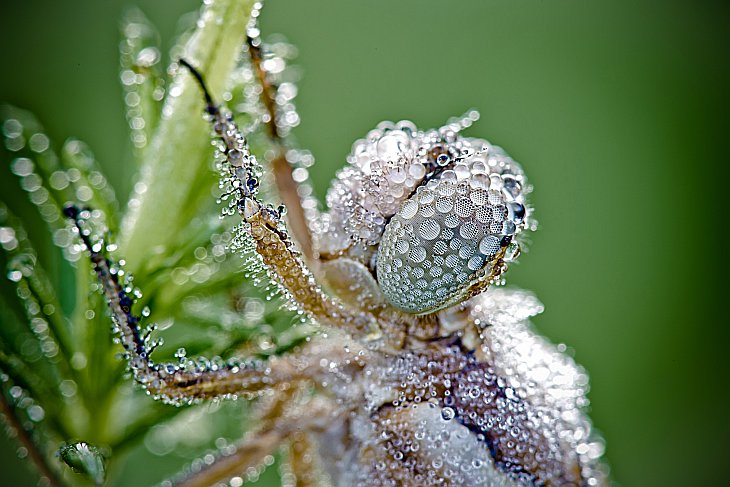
[0,0,730,486]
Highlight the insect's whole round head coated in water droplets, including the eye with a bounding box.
[315,112,536,314]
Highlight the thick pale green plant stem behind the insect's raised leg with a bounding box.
[120,0,253,275]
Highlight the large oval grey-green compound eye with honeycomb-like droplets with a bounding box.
[377,164,526,314]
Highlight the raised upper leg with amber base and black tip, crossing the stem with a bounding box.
[180,59,380,346]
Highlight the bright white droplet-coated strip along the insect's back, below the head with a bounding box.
[458,289,606,485]
